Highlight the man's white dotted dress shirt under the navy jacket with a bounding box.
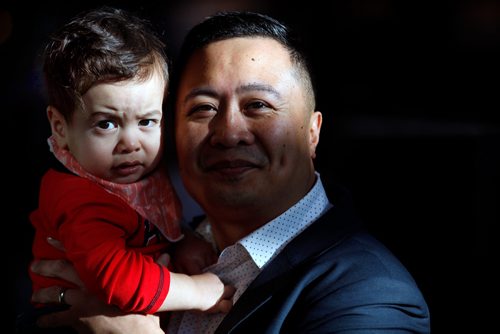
[166,173,331,334]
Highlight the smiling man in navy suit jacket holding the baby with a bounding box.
[29,13,430,333]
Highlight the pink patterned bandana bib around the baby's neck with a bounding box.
[48,136,183,242]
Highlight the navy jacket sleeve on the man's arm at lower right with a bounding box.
[289,237,430,334]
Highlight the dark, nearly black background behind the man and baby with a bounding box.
[0,0,500,333]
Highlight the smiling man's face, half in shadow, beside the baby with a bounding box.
[176,38,321,223]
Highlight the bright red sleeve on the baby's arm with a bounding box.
[32,171,170,313]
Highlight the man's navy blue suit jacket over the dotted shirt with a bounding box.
[216,188,430,334]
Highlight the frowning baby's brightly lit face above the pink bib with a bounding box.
[67,74,165,183]
